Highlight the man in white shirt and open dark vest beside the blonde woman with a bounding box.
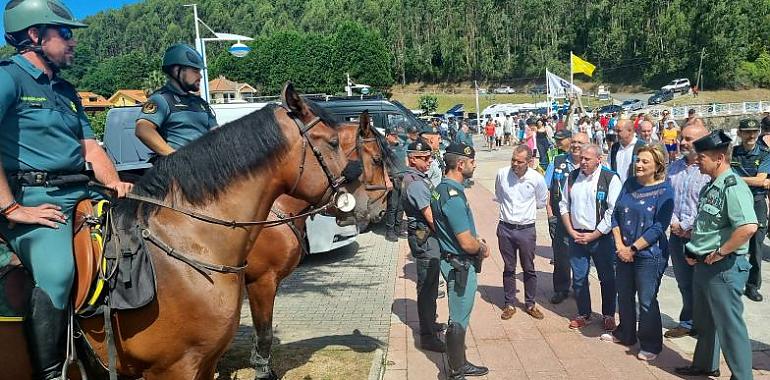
[559,144,623,331]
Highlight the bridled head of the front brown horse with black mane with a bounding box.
[276,83,361,208]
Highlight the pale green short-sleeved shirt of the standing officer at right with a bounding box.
[687,170,757,256]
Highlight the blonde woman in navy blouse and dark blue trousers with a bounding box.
[601,145,674,361]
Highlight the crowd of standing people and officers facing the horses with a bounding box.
[390,106,770,379]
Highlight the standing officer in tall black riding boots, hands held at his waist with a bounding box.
[430,143,489,380]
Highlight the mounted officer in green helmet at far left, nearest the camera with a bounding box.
[0,0,131,379]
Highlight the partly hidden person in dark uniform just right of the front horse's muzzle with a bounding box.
[385,128,408,242]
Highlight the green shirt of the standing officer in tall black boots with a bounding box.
[430,177,476,255]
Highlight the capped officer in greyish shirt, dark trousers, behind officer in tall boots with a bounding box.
[401,141,446,352]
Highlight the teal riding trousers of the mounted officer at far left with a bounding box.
[0,185,92,309]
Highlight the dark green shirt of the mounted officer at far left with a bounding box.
[0,55,94,173]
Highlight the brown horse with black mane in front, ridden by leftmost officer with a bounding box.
[0,84,358,380]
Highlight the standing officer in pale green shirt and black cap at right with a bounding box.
[676,130,757,380]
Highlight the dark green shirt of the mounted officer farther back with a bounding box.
[138,83,217,150]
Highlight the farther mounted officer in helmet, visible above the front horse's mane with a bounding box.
[136,44,217,156]
